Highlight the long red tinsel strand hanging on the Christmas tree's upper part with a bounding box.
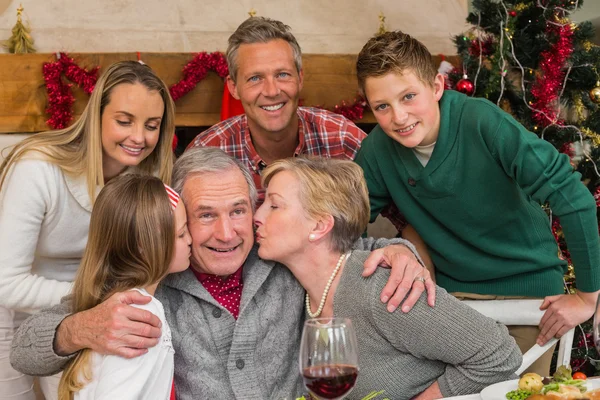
[531,24,573,126]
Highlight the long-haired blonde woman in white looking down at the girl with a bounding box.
[0,61,174,400]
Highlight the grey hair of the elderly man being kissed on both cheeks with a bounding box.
[171,147,258,211]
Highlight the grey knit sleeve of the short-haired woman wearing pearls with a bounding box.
[372,282,522,397]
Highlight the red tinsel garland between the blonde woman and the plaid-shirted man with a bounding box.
[169,52,229,101]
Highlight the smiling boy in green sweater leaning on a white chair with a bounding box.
[356,31,600,376]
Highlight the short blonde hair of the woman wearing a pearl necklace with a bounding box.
[262,157,370,253]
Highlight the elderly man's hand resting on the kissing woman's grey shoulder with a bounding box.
[354,238,435,312]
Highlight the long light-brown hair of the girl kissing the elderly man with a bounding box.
[58,174,175,400]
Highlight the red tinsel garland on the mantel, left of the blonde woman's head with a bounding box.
[42,53,100,129]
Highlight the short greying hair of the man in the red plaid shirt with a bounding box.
[225,17,302,82]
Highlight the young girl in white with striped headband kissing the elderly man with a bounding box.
[58,174,191,400]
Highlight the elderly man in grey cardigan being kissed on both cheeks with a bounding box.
[11,148,423,399]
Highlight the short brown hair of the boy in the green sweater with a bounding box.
[356,31,438,95]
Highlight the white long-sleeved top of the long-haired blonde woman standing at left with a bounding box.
[0,158,92,312]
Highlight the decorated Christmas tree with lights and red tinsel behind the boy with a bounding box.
[447,0,600,373]
